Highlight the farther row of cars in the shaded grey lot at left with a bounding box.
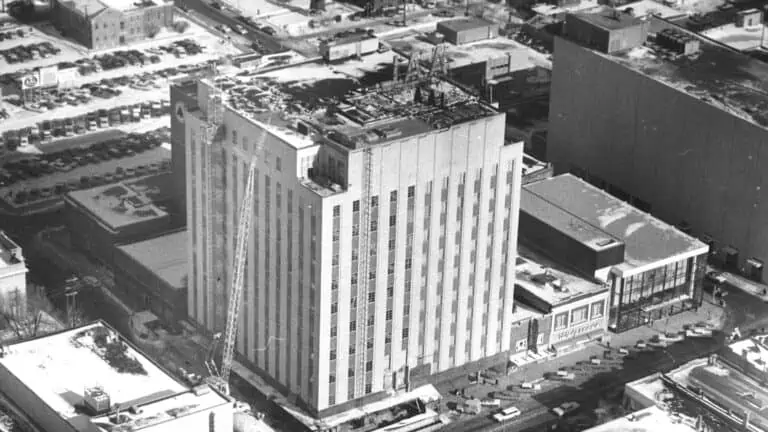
[0,134,168,187]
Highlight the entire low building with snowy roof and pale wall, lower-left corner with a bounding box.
[0,321,233,432]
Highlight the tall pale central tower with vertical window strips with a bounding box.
[181,54,522,417]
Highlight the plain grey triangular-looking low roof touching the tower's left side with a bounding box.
[118,230,188,289]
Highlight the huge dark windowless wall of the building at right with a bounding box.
[547,38,768,274]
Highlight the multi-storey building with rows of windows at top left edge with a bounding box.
[51,0,174,50]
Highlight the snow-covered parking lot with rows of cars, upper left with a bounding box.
[0,16,238,147]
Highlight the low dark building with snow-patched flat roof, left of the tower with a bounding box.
[64,178,171,266]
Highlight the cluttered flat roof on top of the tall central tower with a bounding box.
[204,52,499,150]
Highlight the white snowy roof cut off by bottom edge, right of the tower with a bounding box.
[585,406,696,432]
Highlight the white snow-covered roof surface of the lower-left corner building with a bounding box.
[0,322,229,431]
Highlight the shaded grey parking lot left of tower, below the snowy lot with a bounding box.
[0,128,170,213]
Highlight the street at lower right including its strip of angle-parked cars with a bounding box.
[441,280,768,432]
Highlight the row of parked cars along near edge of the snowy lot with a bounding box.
[0,100,170,151]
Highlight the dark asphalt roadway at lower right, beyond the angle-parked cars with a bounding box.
[443,287,768,432]
